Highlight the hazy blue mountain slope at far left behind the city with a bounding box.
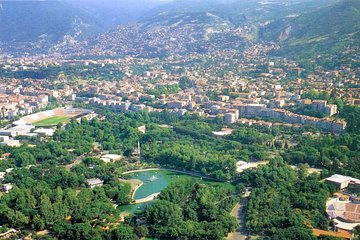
[0,0,164,53]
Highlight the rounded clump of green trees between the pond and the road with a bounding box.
[144,181,237,239]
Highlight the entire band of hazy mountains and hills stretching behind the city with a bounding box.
[0,0,360,57]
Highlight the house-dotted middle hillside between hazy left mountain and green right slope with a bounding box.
[68,0,346,57]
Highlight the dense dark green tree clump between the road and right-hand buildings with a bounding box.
[242,158,330,239]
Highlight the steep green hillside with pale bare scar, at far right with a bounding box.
[259,0,360,57]
